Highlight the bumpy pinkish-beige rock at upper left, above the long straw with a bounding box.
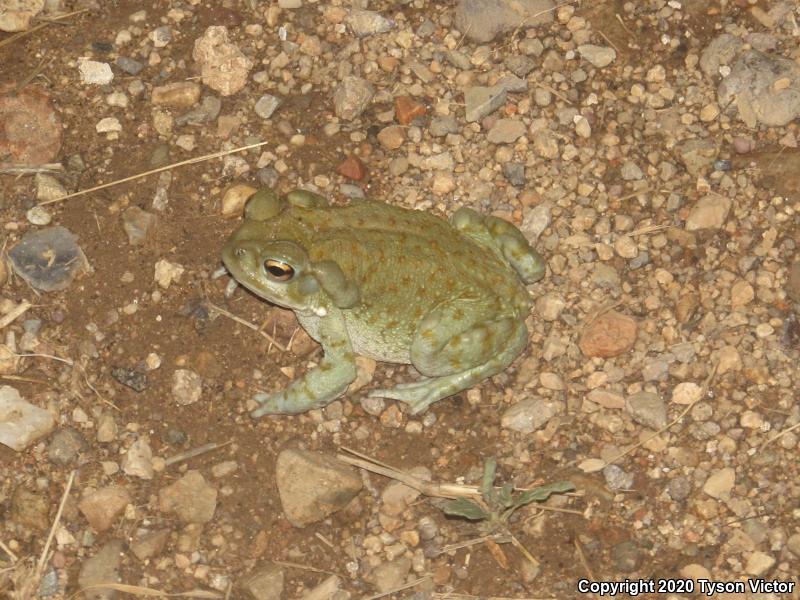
[192,25,253,96]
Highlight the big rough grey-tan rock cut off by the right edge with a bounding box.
[717,50,800,127]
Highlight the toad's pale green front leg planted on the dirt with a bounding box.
[250,308,356,418]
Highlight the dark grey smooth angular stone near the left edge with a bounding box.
[8,225,88,292]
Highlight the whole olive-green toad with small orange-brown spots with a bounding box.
[222,189,545,417]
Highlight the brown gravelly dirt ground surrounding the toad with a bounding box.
[0,0,800,598]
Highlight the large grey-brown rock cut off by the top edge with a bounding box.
[455,0,555,43]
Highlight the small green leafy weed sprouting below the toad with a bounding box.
[443,457,575,531]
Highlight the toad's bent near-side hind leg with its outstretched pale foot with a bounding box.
[370,304,528,414]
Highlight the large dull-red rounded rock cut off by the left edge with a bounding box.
[0,84,61,167]
